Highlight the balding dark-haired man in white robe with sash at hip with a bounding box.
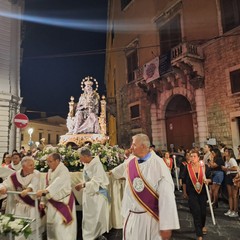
[37,153,77,240]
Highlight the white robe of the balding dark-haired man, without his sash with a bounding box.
[43,162,77,240]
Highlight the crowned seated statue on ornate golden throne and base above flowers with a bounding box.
[59,76,109,147]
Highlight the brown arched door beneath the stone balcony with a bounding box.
[165,95,194,150]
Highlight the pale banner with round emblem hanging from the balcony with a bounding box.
[143,57,159,83]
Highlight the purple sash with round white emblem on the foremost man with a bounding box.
[127,158,159,221]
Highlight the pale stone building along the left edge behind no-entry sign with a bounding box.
[0,0,24,156]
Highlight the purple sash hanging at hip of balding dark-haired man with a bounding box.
[48,192,75,225]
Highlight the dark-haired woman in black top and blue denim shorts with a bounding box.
[208,148,224,208]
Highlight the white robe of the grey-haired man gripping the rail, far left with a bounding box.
[0,170,44,240]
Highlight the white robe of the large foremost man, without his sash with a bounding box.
[112,151,180,240]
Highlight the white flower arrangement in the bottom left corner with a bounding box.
[0,214,32,238]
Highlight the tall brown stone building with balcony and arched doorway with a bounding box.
[105,0,240,152]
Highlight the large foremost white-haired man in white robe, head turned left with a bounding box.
[111,134,180,240]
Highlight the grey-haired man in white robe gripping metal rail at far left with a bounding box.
[0,156,44,240]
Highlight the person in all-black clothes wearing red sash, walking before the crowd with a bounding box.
[181,150,211,240]
